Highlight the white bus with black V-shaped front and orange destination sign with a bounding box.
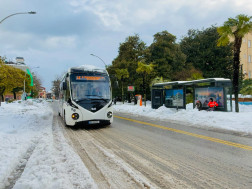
[59,65,113,126]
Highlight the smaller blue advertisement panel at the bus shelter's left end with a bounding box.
[165,89,184,107]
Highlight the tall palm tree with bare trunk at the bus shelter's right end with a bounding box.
[217,14,252,112]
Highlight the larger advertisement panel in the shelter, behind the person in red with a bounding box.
[195,87,224,107]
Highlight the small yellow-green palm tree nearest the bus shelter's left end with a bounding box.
[136,62,154,106]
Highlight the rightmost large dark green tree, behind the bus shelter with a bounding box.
[180,26,233,78]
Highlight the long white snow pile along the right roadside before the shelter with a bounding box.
[113,102,252,134]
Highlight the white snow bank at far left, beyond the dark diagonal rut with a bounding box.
[0,101,52,188]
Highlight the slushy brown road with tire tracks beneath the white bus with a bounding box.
[58,110,252,188]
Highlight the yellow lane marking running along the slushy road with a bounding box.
[114,115,252,150]
